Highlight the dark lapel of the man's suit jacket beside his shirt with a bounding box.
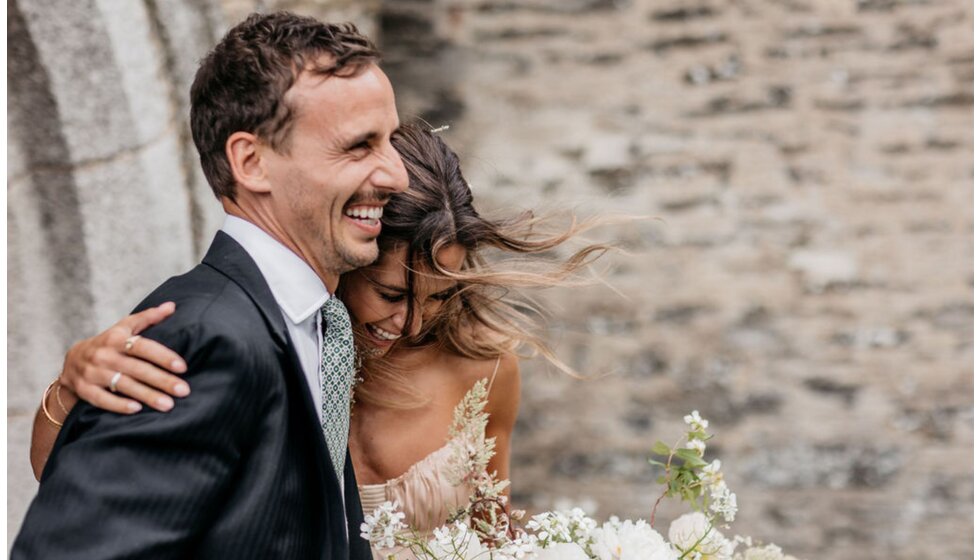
[203,231,350,559]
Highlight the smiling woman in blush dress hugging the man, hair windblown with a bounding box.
[31,126,607,548]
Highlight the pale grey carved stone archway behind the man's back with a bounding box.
[7,0,377,543]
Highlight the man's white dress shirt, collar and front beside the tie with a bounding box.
[221,216,332,422]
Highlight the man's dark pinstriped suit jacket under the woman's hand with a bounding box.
[12,232,371,560]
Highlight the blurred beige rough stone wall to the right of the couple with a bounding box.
[381,0,973,559]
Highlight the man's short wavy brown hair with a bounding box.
[191,12,381,200]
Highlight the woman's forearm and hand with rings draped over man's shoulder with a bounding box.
[31,303,190,480]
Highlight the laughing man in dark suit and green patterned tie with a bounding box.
[13,13,408,560]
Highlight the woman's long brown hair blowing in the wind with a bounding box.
[355,125,611,408]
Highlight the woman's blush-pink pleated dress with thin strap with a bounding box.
[358,358,500,560]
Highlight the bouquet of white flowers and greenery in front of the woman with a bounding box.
[361,381,795,560]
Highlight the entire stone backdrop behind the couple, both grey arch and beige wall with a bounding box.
[7,0,973,560]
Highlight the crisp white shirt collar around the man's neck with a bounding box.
[221,215,330,325]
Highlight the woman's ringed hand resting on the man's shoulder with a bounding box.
[60,302,190,414]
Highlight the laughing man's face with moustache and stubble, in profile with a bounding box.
[265,64,408,277]
